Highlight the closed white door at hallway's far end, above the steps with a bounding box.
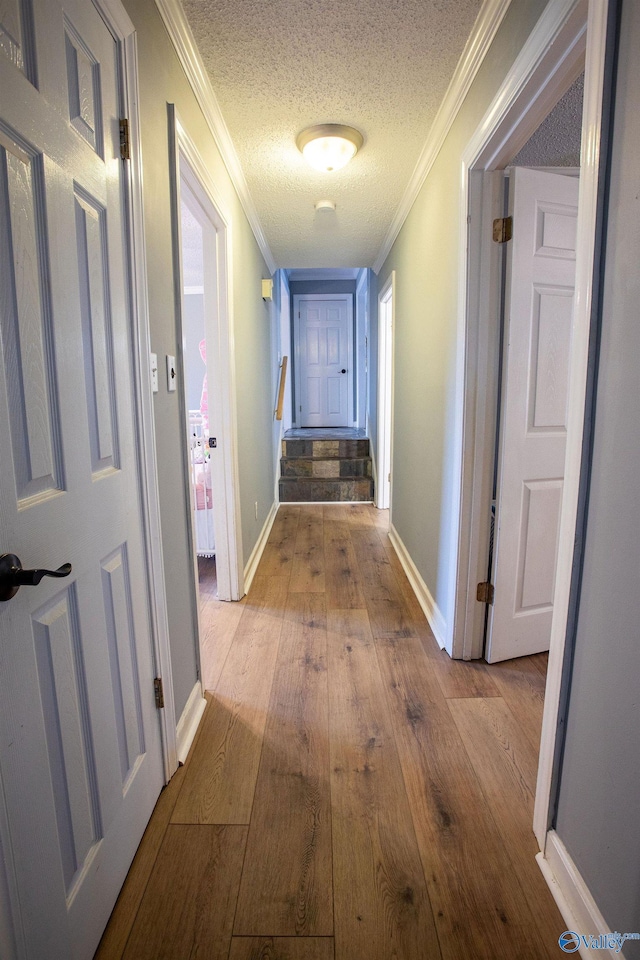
[294,295,353,427]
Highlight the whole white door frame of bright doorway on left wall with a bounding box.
[167,103,244,608]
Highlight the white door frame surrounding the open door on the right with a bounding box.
[448,0,610,852]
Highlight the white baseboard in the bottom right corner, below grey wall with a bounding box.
[536,830,624,960]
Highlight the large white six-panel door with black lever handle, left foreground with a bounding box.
[0,0,163,960]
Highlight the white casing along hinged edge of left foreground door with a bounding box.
[94,0,178,782]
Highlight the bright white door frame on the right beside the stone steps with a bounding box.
[376,270,396,510]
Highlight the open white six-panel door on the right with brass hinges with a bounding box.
[486,168,579,663]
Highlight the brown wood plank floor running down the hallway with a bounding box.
[96,504,565,960]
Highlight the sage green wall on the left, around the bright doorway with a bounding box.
[124,0,274,717]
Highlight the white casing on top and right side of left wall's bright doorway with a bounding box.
[168,110,244,600]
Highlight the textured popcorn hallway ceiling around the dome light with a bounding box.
[182,0,481,267]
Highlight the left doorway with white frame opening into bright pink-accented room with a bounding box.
[169,105,244,702]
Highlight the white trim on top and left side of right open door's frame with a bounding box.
[447,0,592,658]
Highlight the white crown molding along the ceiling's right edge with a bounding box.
[372,0,511,273]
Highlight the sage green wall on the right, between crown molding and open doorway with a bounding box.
[378,0,546,639]
